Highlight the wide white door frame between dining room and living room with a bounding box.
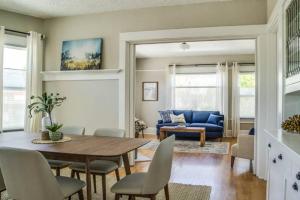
[119,25,277,179]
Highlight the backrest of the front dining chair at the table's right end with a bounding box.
[142,135,175,194]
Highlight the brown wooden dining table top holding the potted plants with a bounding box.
[0,132,150,157]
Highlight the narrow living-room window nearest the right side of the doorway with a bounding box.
[239,72,255,118]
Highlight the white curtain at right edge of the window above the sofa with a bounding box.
[217,63,228,136]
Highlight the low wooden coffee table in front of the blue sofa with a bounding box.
[159,126,205,147]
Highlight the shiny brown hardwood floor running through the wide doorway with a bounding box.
[116,135,266,200]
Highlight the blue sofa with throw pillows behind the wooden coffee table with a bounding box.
[156,110,224,139]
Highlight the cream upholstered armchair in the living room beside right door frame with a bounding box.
[231,134,254,171]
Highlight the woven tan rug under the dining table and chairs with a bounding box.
[1,170,211,200]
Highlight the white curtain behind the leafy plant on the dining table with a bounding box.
[25,32,43,132]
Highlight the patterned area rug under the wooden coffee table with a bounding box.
[140,140,229,155]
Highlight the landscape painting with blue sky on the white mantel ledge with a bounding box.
[60,38,103,71]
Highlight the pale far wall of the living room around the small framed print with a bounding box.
[135,55,255,133]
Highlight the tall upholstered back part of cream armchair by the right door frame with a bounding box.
[237,134,254,160]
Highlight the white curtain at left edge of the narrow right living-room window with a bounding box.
[231,62,240,137]
